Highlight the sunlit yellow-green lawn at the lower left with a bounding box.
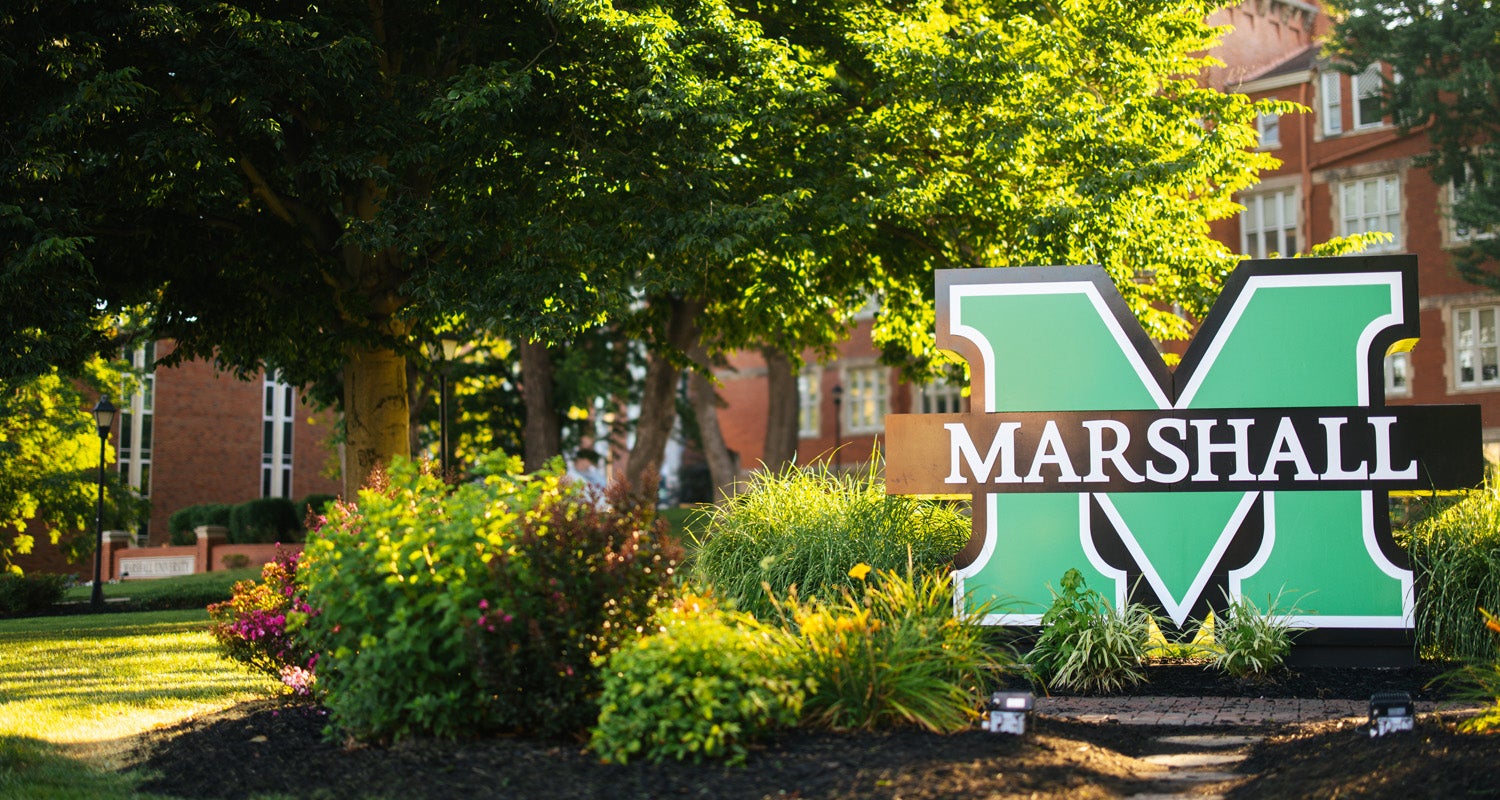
[0,611,275,798]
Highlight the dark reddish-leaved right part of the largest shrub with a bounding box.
[468,471,680,735]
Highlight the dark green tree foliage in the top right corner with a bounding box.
[1329,0,1500,288]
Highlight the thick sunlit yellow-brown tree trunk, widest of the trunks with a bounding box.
[344,344,411,500]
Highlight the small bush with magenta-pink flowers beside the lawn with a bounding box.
[209,548,318,695]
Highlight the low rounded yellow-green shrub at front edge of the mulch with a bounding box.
[590,596,807,764]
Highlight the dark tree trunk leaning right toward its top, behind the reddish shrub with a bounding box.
[626,297,704,491]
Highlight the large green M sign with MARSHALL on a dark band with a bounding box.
[887,255,1484,653]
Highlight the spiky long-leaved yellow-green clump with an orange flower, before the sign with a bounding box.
[782,564,1014,732]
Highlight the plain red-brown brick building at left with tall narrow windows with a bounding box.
[17,342,342,572]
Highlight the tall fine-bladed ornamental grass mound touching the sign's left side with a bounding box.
[693,462,971,618]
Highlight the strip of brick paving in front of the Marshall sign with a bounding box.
[1035,696,1478,725]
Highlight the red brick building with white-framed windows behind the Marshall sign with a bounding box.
[719,0,1500,470]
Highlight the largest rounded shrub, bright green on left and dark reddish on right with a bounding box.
[303,455,672,738]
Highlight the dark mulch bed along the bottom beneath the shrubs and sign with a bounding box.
[135,665,1500,800]
